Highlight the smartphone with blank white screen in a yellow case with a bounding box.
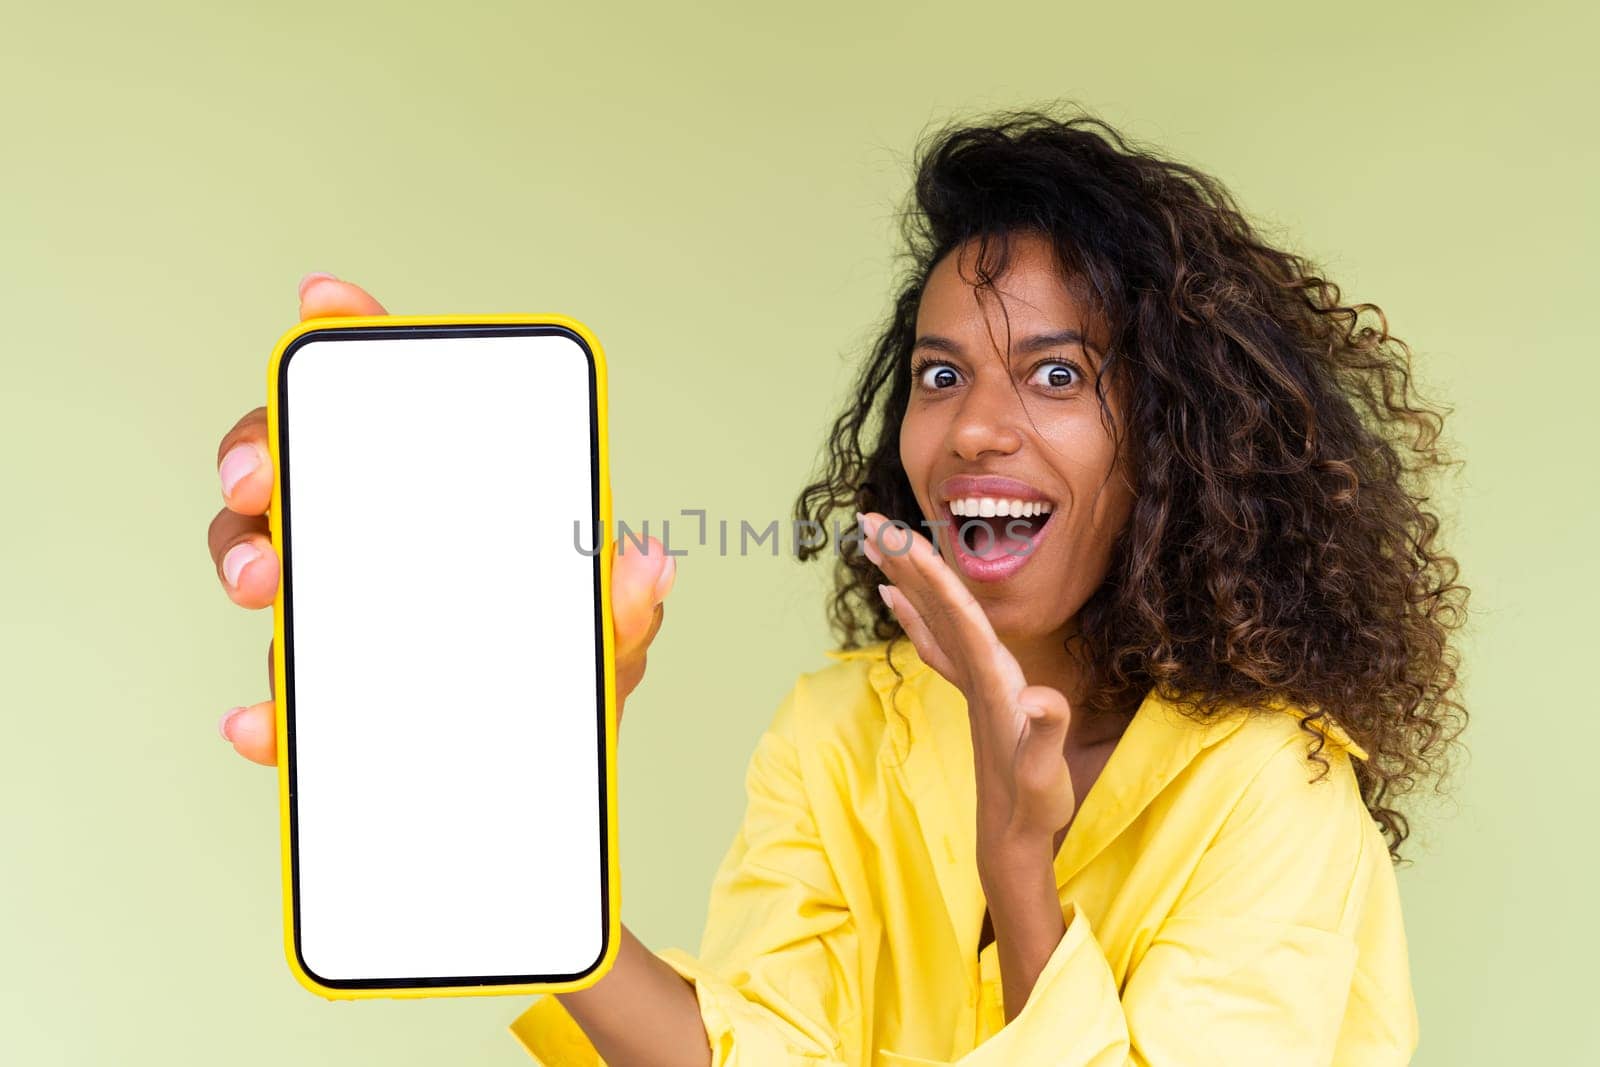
[267,315,621,1000]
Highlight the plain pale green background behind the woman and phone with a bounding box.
[0,2,1600,1067]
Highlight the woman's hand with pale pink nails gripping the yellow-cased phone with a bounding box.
[206,274,675,766]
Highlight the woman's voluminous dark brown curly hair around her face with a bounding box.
[795,106,1469,862]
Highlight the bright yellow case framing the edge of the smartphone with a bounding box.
[267,314,622,1000]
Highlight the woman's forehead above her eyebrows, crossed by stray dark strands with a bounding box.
[917,234,1093,339]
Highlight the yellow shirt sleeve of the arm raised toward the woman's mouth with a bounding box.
[885,742,1414,1067]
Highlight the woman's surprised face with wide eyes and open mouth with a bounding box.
[899,234,1133,638]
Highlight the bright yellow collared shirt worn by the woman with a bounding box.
[510,638,1418,1067]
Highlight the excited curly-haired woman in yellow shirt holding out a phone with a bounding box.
[210,103,1466,1067]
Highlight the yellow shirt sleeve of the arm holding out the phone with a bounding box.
[510,689,861,1067]
